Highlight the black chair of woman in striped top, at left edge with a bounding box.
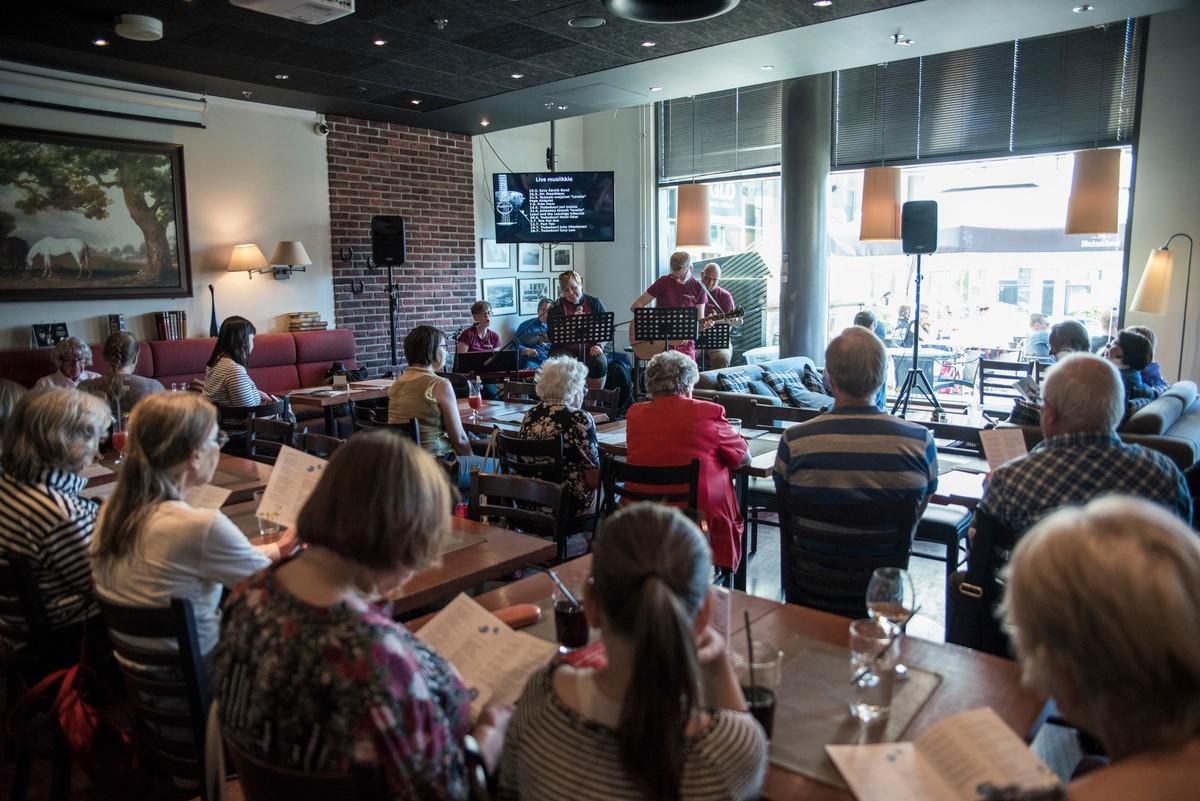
[0,555,72,801]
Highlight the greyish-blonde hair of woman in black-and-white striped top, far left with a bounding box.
[0,387,113,478]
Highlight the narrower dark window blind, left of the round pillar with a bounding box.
[658,82,782,183]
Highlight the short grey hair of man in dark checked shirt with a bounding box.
[1042,354,1124,433]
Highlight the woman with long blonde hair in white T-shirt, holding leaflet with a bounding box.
[91,392,294,656]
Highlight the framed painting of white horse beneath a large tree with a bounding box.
[0,127,192,301]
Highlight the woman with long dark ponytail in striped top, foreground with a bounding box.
[500,504,767,801]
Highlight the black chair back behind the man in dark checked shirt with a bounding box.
[946,510,1017,658]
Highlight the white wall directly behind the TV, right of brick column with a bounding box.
[463,116,592,341]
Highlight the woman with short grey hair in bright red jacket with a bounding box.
[625,350,750,570]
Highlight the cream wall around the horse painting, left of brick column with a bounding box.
[0,97,334,348]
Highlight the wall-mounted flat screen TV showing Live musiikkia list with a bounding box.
[492,171,616,242]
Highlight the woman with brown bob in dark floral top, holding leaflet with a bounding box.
[216,430,508,801]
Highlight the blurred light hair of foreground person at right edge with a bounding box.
[1003,495,1200,759]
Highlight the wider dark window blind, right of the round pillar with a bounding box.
[833,19,1146,169]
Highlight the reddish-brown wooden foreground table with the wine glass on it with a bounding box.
[407,555,1045,801]
